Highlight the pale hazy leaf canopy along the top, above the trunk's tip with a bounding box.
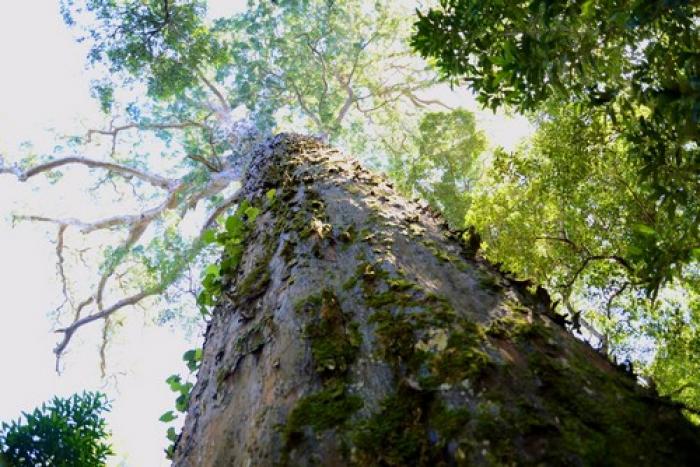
[62,0,435,139]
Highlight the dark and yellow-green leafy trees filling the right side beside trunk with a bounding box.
[413,0,700,416]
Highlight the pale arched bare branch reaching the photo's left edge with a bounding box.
[0,156,173,190]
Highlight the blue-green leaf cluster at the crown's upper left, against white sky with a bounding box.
[61,0,227,100]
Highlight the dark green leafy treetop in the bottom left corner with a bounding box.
[0,392,112,467]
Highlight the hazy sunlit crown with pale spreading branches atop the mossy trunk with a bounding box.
[0,0,436,369]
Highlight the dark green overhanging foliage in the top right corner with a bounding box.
[413,0,700,294]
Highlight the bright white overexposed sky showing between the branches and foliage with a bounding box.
[0,0,531,467]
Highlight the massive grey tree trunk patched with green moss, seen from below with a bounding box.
[175,135,700,466]
